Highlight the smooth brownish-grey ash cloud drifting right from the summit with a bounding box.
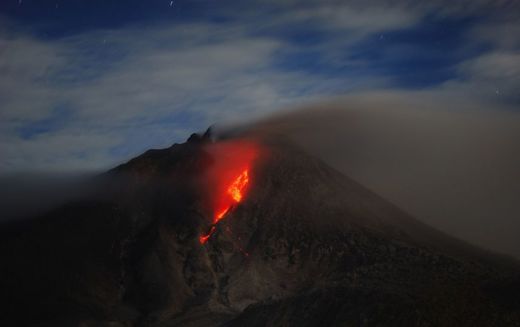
[242,92,520,258]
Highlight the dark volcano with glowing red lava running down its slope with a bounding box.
[0,133,520,327]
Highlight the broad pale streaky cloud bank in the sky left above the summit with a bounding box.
[0,24,354,171]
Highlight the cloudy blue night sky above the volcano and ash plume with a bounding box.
[0,0,520,173]
